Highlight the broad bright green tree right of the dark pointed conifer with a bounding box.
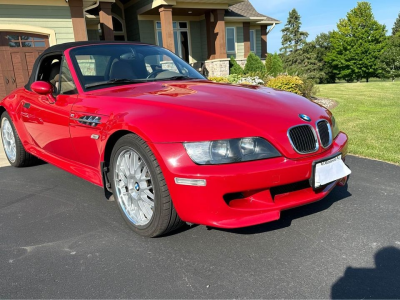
[326,2,386,82]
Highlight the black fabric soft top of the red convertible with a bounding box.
[25,41,148,90]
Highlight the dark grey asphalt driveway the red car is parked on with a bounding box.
[0,156,400,298]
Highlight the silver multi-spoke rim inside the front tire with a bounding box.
[114,149,154,226]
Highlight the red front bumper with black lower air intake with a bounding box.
[151,132,347,228]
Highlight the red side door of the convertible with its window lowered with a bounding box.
[21,57,77,160]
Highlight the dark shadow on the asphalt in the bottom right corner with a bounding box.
[331,247,400,299]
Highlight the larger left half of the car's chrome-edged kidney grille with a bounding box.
[288,125,318,154]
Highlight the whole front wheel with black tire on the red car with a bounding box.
[110,134,183,237]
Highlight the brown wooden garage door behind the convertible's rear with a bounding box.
[0,32,49,98]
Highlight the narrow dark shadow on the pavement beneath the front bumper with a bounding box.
[207,183,351,234]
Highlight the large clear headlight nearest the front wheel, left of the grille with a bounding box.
[183,137,281,165]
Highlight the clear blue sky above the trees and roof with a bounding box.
[250,0,400,53]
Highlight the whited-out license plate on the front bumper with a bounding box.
[313,154,351,188]
